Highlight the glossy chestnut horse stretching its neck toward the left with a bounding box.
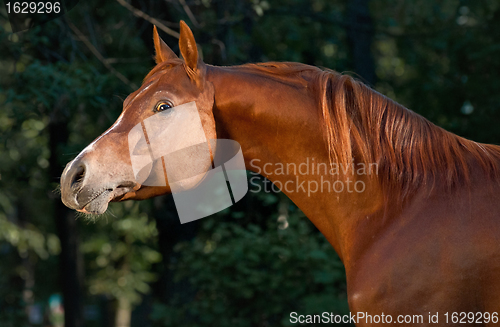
[61,22,500,326]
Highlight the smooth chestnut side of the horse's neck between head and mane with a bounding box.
[208,67,381,257]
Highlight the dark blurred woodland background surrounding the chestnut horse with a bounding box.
[0,0,500,327]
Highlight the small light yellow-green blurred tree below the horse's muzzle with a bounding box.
[82,202,161,327]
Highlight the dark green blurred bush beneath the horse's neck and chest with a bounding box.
[151,201,348,326]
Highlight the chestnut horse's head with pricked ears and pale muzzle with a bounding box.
[61,21,217,214]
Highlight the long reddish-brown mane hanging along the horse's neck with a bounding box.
[239,63,500,194]
